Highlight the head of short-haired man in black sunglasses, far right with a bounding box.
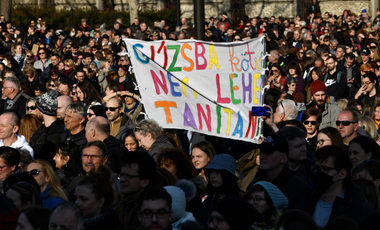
[335,109,359,152]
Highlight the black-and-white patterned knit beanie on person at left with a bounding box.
[36,90,58,116]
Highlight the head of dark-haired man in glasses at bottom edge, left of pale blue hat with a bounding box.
[138,186,173,230]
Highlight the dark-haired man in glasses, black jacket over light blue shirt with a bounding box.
[299,145,380,229]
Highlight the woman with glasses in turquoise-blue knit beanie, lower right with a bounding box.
[244,181,289,230]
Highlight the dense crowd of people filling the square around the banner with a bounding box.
[0,0,380,230]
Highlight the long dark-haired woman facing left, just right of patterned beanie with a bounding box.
[76,81,102,108]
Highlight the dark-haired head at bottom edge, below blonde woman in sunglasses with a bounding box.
[21,207,50,230]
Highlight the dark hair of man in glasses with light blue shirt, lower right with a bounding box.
[314,145,352,179]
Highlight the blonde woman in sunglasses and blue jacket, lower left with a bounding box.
[27,160,67,210]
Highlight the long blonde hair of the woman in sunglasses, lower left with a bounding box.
[31,159,68,201]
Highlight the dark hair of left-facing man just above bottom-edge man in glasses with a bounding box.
[121,151,157,184]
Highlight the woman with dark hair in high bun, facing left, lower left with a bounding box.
[75,165,121,230]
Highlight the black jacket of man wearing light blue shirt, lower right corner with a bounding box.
[298,179,380,230]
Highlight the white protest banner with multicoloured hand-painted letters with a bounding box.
[124,38,265,142]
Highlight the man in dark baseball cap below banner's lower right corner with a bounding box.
[247,134,311,209]
